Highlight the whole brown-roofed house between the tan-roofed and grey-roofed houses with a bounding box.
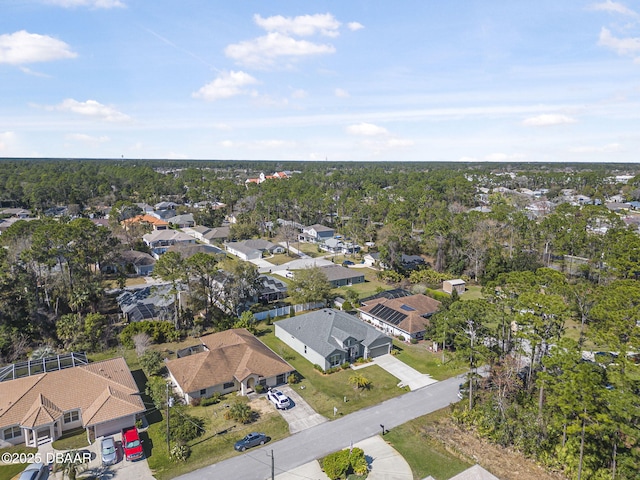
[166,328,294,402]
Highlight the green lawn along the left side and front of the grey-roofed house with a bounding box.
[260,328,406,418]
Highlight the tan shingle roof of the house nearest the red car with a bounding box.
[0,358,145,428]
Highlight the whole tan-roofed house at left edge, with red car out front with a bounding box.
[0,357,145,447]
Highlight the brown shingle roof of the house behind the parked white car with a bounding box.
[167,328,294,393]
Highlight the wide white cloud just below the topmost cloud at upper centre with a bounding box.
[224,32,336,68]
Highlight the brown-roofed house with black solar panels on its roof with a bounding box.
[358,294,440,341]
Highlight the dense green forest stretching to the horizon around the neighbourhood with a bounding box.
[0,159,640,479]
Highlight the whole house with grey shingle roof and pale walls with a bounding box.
[274,308,392,370]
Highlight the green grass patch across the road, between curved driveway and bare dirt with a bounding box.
[384,408,471,480]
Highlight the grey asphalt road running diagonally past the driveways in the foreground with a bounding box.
[177,377,461,480]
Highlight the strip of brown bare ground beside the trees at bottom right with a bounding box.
[423,418,566,480]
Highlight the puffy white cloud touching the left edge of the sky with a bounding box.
[0,30,77,65]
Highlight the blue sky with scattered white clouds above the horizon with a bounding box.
[0,0,640,162]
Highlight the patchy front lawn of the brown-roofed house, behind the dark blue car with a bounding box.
[148,395,289,480]
